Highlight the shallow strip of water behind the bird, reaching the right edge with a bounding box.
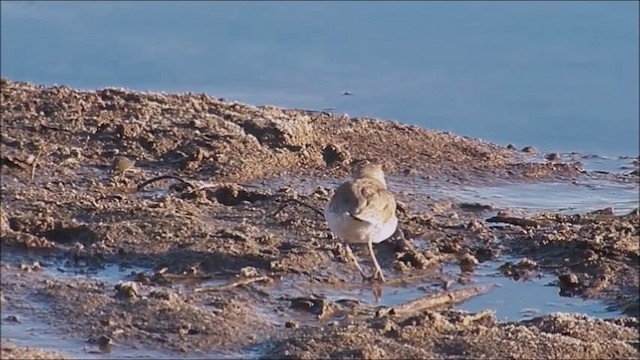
[258,167,640,215]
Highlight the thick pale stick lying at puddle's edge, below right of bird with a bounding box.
[376,286,490,317]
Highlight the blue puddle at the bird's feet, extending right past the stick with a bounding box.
[264,259,624,321]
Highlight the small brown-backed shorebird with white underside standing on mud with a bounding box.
[324,162,398,282]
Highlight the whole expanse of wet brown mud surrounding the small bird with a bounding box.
[0,79,640,359]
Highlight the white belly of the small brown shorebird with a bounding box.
[324,202,398,244]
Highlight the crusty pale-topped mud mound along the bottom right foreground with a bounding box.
[264,311,638,359]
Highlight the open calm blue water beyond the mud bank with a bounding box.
[1,1,640,156]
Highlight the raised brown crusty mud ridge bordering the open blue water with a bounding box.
[0,79,592,186]
